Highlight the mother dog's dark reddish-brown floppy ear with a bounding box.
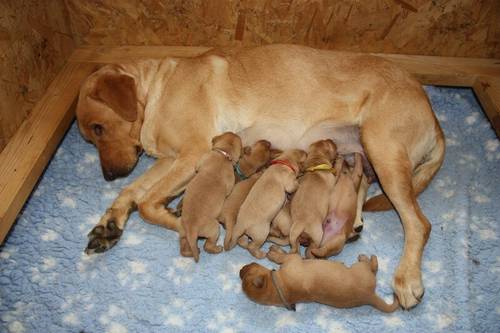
[91,74,137,122]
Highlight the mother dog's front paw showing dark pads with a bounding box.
[85,218,123,254]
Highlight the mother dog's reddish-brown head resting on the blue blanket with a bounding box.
[76,65,142,180]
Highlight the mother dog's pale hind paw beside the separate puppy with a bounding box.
[392,263,425,310]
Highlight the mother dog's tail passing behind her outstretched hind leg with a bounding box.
[363,124,445,212]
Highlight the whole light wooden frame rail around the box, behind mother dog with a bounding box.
[0,46,500,243]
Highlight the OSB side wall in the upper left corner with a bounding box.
[0,0,74,151]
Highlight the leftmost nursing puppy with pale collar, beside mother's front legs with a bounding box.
[180,132,241,262]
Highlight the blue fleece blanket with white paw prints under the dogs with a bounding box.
[0,87,500,333]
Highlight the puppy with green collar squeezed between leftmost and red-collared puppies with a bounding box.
[218,140,276,251]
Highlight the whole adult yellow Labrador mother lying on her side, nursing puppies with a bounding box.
[77,45,445,308]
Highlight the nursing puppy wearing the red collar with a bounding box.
[229,149,307,259]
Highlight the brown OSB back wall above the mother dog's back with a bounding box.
[66,0,500,57]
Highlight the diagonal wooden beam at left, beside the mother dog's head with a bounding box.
[0,63,95,243]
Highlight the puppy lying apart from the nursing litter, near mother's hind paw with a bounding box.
[240,246,399,312]
